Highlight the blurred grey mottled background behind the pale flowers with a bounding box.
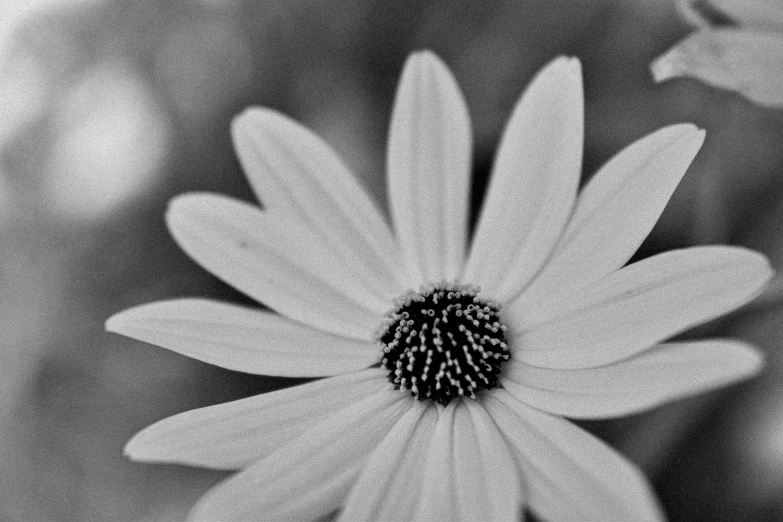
[0,0,783,521]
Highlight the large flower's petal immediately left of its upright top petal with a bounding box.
[231,107,412,297]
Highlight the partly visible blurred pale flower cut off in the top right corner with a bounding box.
[650,0,783,107]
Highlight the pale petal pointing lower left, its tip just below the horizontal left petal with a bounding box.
[125,368,393,469]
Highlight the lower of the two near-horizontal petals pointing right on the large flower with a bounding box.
[501,340,763,419]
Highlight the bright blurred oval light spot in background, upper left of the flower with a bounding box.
[43,64,171,220]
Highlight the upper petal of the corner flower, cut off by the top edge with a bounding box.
[676,0,783,31]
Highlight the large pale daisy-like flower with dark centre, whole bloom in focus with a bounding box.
[106,52,771,520]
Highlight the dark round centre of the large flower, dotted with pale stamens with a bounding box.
[377,284,509,406]
